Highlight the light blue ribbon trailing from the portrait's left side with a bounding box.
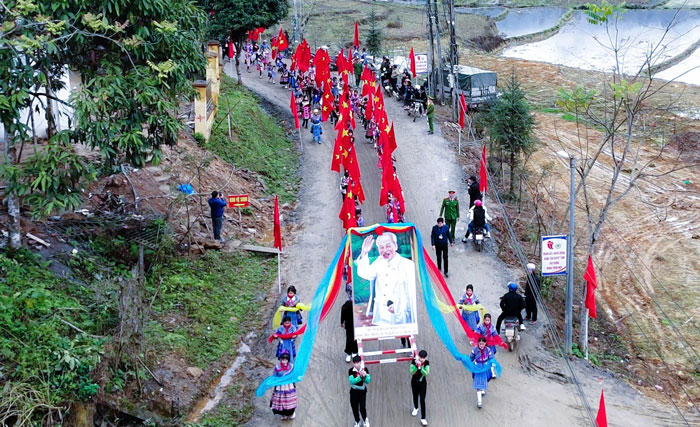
[255,234,348,396]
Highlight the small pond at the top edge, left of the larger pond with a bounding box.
[496,7,567,38]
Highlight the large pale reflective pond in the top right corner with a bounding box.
[503,10,700,84]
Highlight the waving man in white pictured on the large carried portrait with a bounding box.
[357,232,416,325]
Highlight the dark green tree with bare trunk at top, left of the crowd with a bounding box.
[200,0,291,84]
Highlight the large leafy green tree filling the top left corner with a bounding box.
[0,0,206,247]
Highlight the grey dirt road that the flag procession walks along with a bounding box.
[227,64,683,426]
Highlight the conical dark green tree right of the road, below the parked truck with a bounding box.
[487,74,535,195]
